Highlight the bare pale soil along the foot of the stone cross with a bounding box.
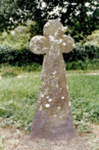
[0,125,99,150]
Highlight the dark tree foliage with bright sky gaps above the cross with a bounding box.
[0,0,99,41]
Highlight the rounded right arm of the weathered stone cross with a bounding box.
[62,35,75,53]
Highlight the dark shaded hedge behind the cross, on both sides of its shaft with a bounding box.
[0,45,99,70]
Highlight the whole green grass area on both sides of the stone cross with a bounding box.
[0,63,99,132]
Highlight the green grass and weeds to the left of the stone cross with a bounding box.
[0,72,41,129]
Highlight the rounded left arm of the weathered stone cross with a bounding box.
[30,36,48,54]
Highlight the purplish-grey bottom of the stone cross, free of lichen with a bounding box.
[31,111,76,141]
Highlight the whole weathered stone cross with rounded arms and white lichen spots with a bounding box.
[30,20,75,140]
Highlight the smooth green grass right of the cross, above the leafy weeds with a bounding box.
[68,75,99,101]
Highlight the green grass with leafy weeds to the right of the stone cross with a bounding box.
[67,75,99,123]
